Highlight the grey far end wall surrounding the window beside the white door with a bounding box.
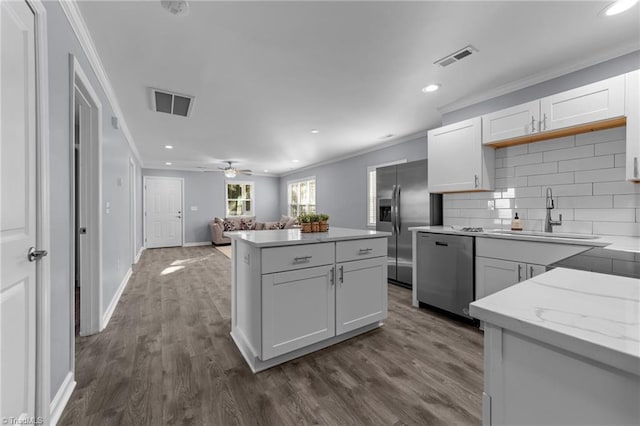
[140,169,284,244]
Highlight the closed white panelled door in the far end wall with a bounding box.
[144,176,183,248]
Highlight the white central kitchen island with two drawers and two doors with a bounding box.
[225,228,389,373]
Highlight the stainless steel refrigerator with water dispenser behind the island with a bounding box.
[376,160,442,288]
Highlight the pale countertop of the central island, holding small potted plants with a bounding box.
[224,227,391,247]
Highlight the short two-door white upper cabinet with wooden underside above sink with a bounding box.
[482,75,624,147]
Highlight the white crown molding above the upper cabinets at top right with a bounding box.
[438,41,640,114]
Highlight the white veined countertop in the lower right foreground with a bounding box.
[470,268,640,375]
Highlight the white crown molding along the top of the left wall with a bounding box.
[58,0,144,168]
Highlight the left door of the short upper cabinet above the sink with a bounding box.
[482,100,540,144]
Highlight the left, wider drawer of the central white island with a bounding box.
[262,243,335,274]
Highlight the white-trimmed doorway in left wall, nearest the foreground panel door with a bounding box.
[70,55,102,336]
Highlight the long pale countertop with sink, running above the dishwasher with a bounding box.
[409,226,640,253]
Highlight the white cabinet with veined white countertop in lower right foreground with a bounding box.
[470,268,640,425]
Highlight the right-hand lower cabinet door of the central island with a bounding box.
[336,257,387,334]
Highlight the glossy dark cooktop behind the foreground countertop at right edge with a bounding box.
[549,247,640,278]
